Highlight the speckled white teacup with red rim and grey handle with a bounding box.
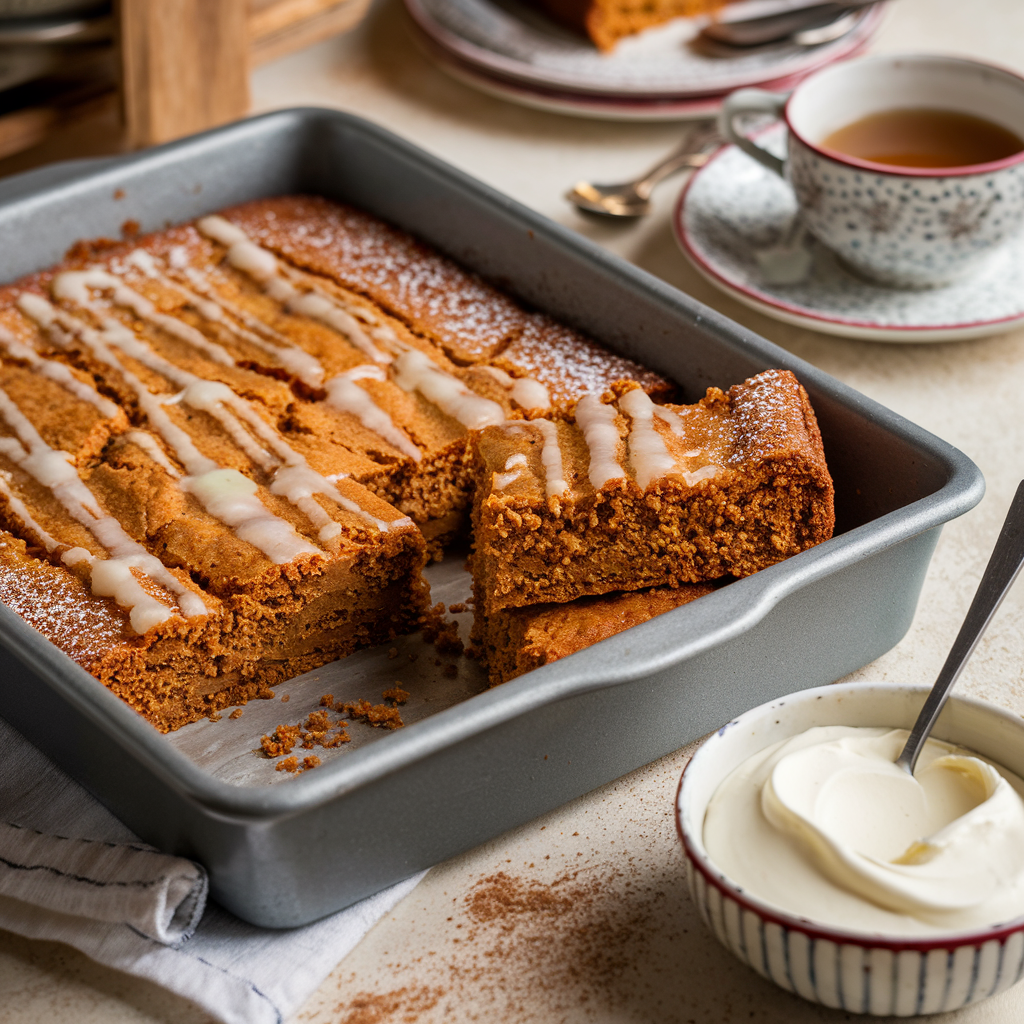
[720,55,1024,288]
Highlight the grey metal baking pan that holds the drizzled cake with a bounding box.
[0,110,984,927]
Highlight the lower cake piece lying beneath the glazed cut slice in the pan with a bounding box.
[474,583,714,686]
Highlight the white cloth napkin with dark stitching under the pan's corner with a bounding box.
[0,719,425,1024]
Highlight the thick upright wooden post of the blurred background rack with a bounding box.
[117,0,249,146]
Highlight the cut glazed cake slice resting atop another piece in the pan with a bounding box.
[472,370,835,615]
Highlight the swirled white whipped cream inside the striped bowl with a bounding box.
[703,726,1024,935]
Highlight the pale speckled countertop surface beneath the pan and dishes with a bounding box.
[0,0,1024,1024]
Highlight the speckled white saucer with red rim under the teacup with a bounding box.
[673,125,1024,343]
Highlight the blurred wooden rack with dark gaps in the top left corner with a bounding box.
[0,0,370,174]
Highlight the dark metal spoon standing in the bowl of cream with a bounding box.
[896,481,1024,775]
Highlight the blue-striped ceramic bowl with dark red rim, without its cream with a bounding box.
[676,683,1024,1017]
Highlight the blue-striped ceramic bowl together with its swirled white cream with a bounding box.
[677,683,1024,1016]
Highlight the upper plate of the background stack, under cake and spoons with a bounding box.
[404,0,883,99]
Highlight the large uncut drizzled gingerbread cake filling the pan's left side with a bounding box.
[0,197,673,730]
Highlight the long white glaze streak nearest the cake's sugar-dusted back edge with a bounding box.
[196,216,391,364]
